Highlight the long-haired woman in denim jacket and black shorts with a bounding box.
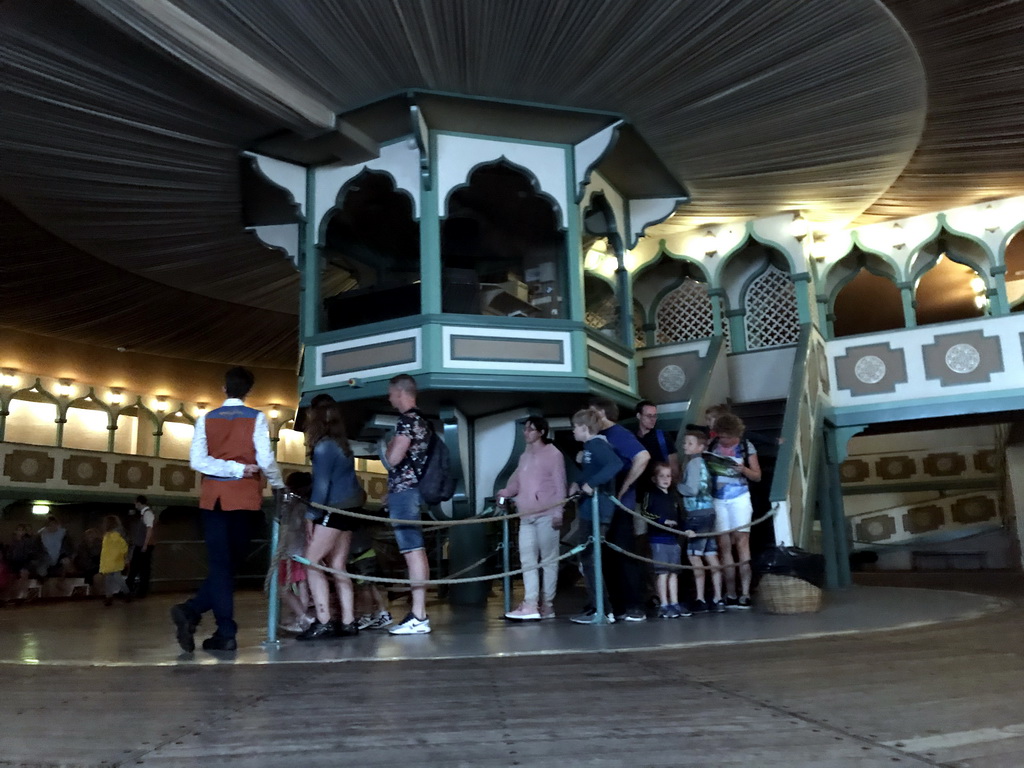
[298,402,367,641]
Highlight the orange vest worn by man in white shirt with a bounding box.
[199,406,263,510]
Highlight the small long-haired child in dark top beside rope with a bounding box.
[643,462,690,618]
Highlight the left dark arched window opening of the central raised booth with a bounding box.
[321,171,420,331]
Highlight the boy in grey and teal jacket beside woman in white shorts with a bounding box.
[676,430,725,613]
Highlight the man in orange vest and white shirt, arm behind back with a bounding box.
[171,368,285,653]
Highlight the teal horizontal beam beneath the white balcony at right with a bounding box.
[826,388,1024,426]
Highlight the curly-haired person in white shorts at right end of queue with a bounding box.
[708,414,761,608]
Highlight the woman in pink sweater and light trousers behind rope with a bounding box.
[498,416,565,622]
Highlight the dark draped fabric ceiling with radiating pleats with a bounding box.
[0,0,1024,367]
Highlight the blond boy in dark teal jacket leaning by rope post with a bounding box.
[569,409,623,624]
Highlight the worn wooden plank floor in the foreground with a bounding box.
[0,575,1024,768]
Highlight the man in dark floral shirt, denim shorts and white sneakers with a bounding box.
[385,374,432,635]
